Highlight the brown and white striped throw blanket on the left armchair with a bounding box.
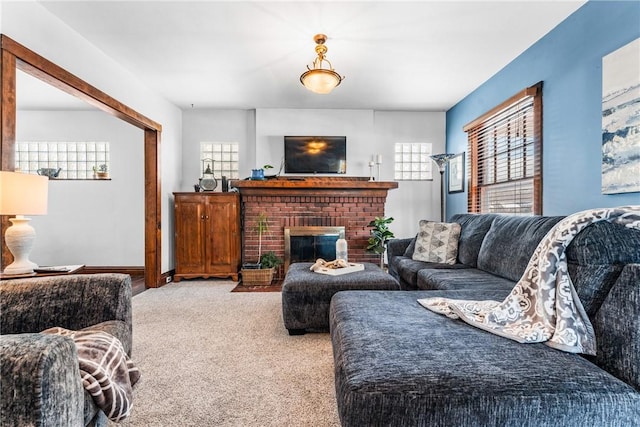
[42,327,140,422]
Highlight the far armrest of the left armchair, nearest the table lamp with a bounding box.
[0,274,131,334]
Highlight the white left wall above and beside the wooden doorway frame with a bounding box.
[0,1,182,272]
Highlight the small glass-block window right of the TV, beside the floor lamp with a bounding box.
[393,142,433,181]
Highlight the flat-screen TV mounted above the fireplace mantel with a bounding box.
[284,136,347,173]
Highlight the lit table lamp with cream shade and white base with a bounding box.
[0,171,49,275]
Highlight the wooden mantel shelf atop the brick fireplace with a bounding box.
[231,177,398,197]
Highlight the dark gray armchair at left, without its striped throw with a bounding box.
[0,274,132,426]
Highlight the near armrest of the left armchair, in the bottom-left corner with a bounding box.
[0,334,84,426]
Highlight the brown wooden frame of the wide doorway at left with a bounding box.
[0,34,162,288]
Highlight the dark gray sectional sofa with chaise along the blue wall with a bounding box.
[330,214,640,427]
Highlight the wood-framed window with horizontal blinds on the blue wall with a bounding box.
[464,82,542,215]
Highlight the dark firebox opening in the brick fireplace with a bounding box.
[284,226,345,271]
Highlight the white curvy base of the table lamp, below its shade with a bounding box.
[3,215,38,275]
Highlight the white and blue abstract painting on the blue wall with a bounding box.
[602,39,640,194]
